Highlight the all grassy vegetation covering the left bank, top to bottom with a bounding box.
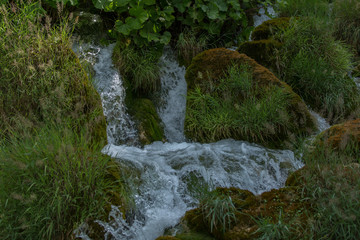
[0,1,129,239]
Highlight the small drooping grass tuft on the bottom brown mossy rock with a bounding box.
[199,190,238,233]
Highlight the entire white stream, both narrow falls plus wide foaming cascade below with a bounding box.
[71,45,302,240]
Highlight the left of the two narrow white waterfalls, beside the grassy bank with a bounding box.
[73,44,138,145]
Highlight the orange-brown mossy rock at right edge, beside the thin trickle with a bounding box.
[313,118,360,159]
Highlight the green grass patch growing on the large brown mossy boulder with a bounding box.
[185,65,292,144]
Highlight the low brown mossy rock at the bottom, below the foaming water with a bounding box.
[183,187,308,239]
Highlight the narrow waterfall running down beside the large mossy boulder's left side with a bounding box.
[158,47,187,142]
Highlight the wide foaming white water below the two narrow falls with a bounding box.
[98,140,303,240]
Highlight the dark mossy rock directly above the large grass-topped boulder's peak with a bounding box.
[237,39,282,72]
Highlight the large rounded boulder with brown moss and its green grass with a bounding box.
[185,48,315,147]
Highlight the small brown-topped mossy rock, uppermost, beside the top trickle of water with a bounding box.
[251,17,291,41]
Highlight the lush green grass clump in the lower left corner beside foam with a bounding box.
[0,127,128,239]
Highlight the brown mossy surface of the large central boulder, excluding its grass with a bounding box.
[185,48,316,147]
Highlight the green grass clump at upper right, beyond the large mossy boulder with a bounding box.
[278,18,360,122]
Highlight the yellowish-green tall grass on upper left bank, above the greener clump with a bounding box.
[0,1,106,140]
